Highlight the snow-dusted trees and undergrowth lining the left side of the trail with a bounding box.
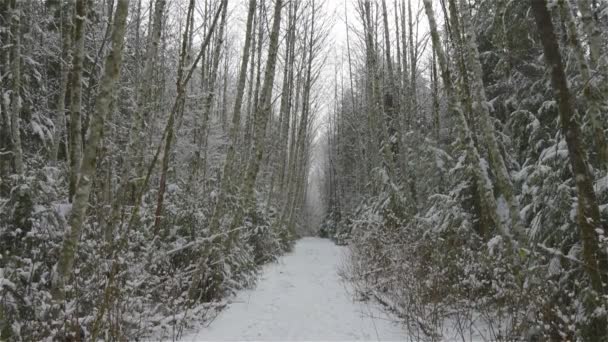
[0,0,327,341]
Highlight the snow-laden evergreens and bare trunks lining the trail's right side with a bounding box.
[321,0,608,341]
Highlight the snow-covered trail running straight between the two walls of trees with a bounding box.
[182,238,405,341]
